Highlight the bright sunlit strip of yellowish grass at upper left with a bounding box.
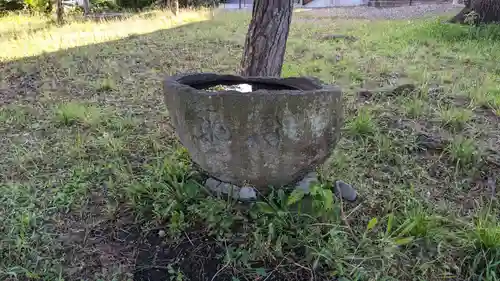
[0,10,211,61]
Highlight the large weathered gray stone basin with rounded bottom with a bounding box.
[164,73,342,189]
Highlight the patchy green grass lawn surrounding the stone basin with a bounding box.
[0,6,500,281]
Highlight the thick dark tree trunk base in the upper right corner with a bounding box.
[450,0,500,25]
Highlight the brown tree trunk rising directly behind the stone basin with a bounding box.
[241,0,293,77]
